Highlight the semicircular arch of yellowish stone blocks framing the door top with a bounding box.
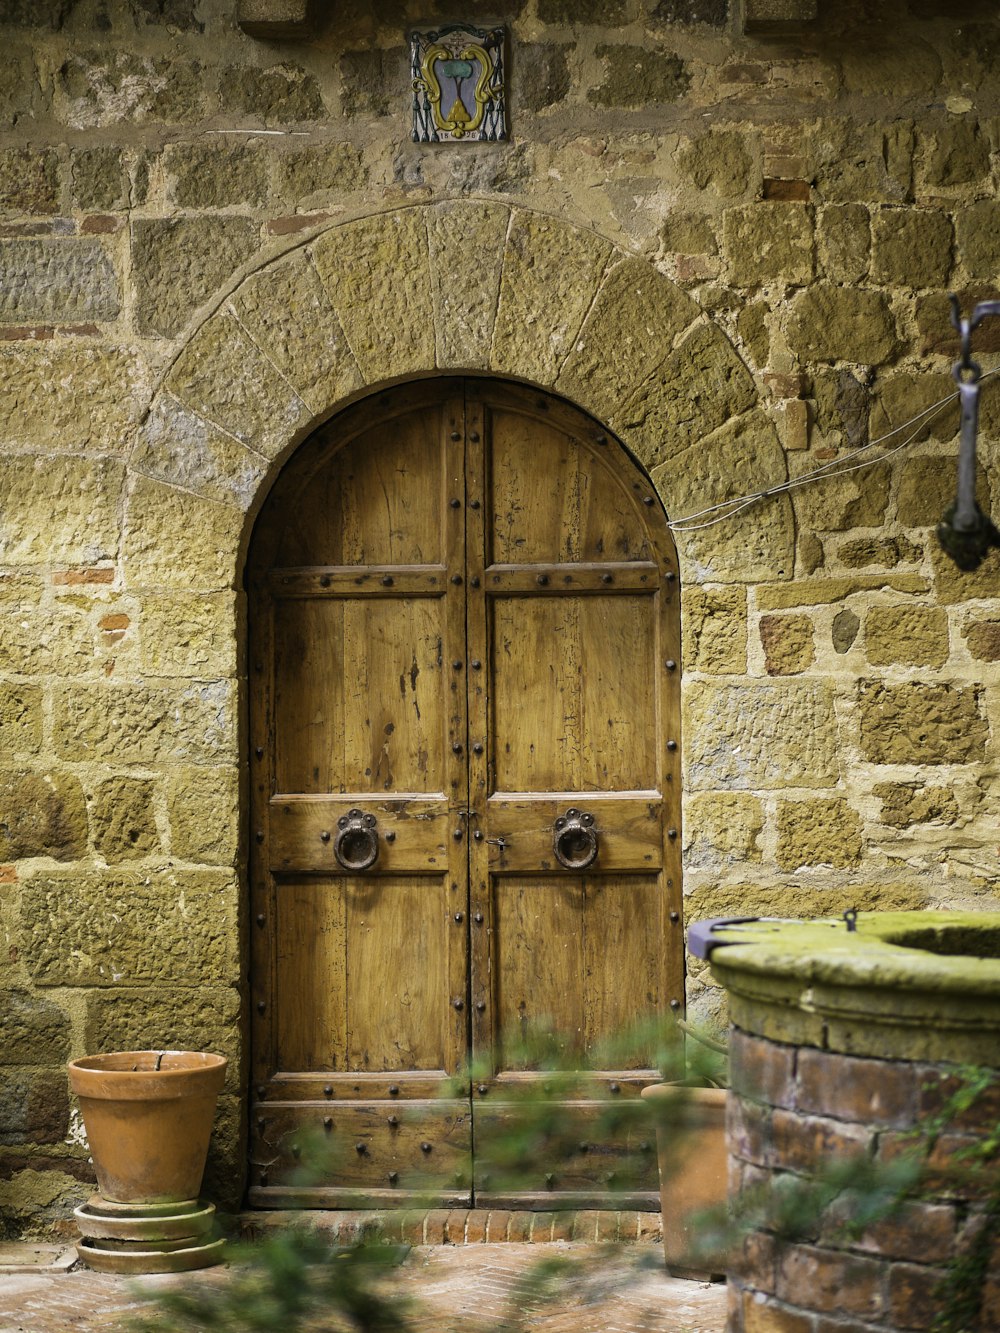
[125,201,793,587]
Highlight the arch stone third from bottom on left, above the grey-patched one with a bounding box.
[164,311,312,459]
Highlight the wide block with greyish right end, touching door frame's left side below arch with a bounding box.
[53,680,236,764]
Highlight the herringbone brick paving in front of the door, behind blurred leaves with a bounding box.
[0,1241,725,1333]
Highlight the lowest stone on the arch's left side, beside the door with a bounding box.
[123,477,244,592]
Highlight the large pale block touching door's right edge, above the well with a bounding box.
[684,681,840,790]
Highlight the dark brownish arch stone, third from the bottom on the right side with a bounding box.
[608,323,757,468]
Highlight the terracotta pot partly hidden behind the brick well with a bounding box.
[643,1084,728,1277]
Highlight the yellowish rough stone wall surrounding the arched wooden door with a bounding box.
[0,0,1000,1225]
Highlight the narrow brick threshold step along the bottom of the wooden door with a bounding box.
[239,1208,663,1245]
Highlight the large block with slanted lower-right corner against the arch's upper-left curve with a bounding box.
[132,217,260,337]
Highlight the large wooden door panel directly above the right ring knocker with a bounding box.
[489,589,657,792]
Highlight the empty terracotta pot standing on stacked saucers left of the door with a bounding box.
[69,1050,228,1204]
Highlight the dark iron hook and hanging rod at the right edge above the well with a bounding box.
[937,293,1000,569]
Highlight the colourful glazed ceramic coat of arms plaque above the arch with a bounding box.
[411,24,507,144]
